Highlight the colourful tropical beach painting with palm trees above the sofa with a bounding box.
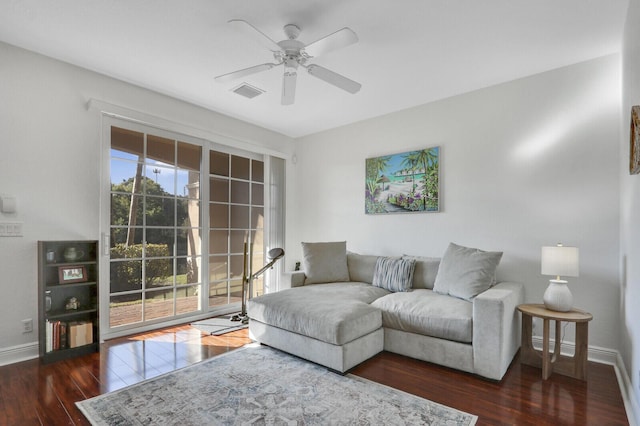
[365,146,440,214]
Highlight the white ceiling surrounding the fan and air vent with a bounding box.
[0,0,628,137]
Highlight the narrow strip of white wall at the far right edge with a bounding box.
[620,0,640,415]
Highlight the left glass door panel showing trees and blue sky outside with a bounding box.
[109,126,202,328]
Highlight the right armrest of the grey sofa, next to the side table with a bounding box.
[473,282,524,380]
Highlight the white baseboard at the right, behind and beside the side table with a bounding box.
[531,336,640,426]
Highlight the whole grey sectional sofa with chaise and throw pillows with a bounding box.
[247,242,524,380]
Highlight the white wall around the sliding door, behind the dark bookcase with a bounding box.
[0,43,293,363]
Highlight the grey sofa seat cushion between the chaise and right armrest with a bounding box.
[371,289,473,343]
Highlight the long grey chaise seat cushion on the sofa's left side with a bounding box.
[247,282,389,345]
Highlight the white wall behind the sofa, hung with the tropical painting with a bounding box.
[287,55,620,349]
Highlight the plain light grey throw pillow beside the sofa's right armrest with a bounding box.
[433,243,502,300]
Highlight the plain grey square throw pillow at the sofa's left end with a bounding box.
[302,241,349,284]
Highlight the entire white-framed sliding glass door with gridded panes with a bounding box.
[101,118,284,338]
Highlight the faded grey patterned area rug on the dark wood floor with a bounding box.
[76,345,477,426]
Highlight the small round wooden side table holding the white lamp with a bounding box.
[518,304,593,380]
